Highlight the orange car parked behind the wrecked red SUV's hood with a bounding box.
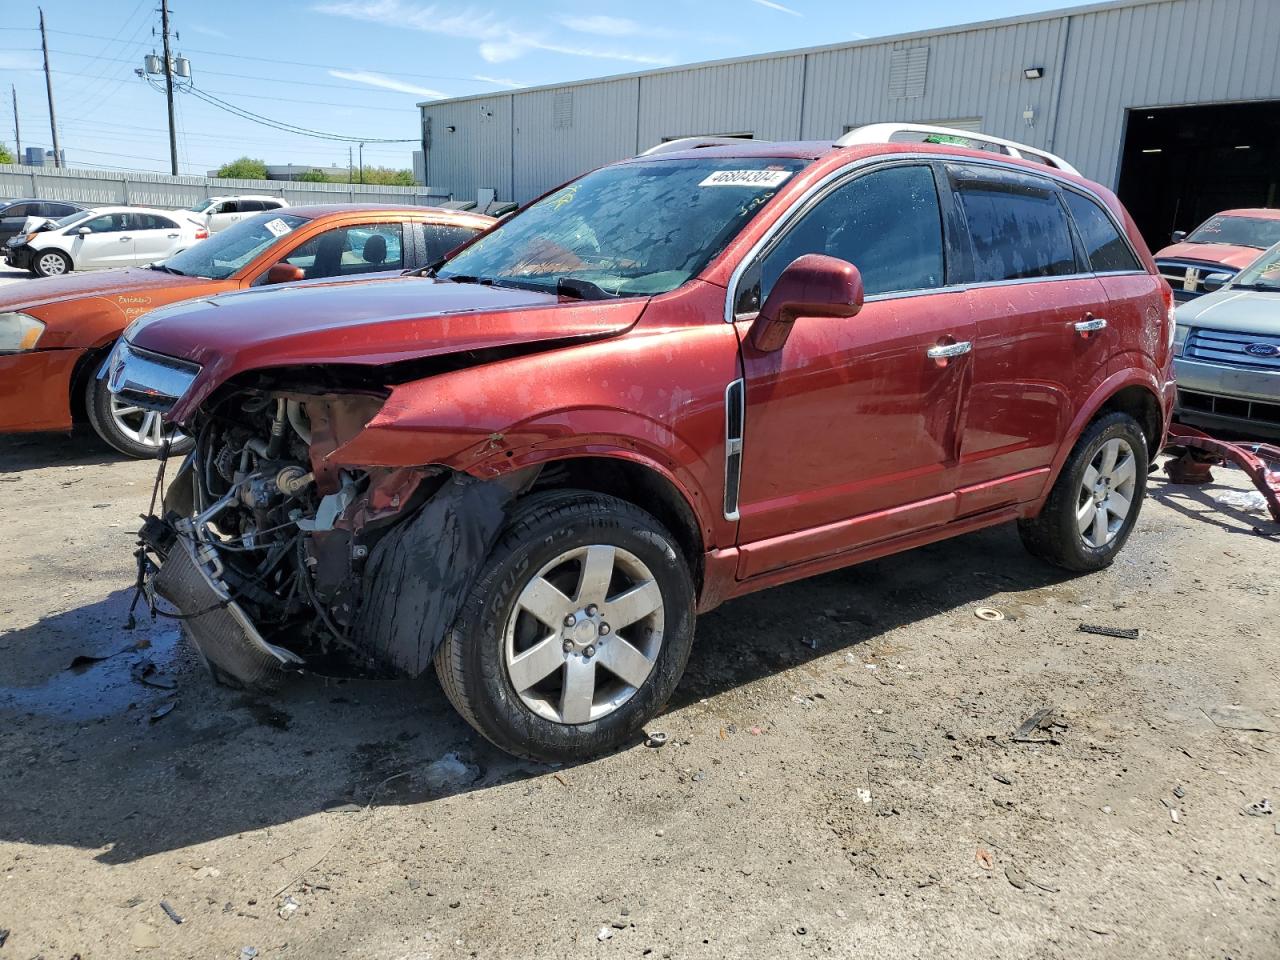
[0,204,494,457]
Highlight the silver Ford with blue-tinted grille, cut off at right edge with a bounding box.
[1174,243,1280,436]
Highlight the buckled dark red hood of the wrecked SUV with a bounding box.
[128,276,648,421]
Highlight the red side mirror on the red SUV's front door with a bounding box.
[751,253,863,353]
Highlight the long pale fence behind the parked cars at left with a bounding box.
[0,164,452,209]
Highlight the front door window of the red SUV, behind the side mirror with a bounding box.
[736,165,945,314]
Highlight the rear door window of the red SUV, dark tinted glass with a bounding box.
[950,165,1079,283]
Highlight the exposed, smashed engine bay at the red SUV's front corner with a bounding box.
[138,389,520,686]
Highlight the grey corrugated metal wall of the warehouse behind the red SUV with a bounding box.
[422,0,1280,201]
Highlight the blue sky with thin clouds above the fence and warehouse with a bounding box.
[0,0,1095,173]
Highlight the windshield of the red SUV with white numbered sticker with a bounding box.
[438,157,806,296]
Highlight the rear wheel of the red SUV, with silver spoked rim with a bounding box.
[1018,411,1151,572]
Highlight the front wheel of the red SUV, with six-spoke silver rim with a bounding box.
[435,492,694,762]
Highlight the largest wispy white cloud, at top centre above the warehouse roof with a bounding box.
[314,0,672,65]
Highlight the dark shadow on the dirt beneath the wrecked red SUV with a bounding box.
[0,527,1066,864]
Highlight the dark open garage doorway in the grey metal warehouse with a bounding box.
[1116,100,1280,251]
